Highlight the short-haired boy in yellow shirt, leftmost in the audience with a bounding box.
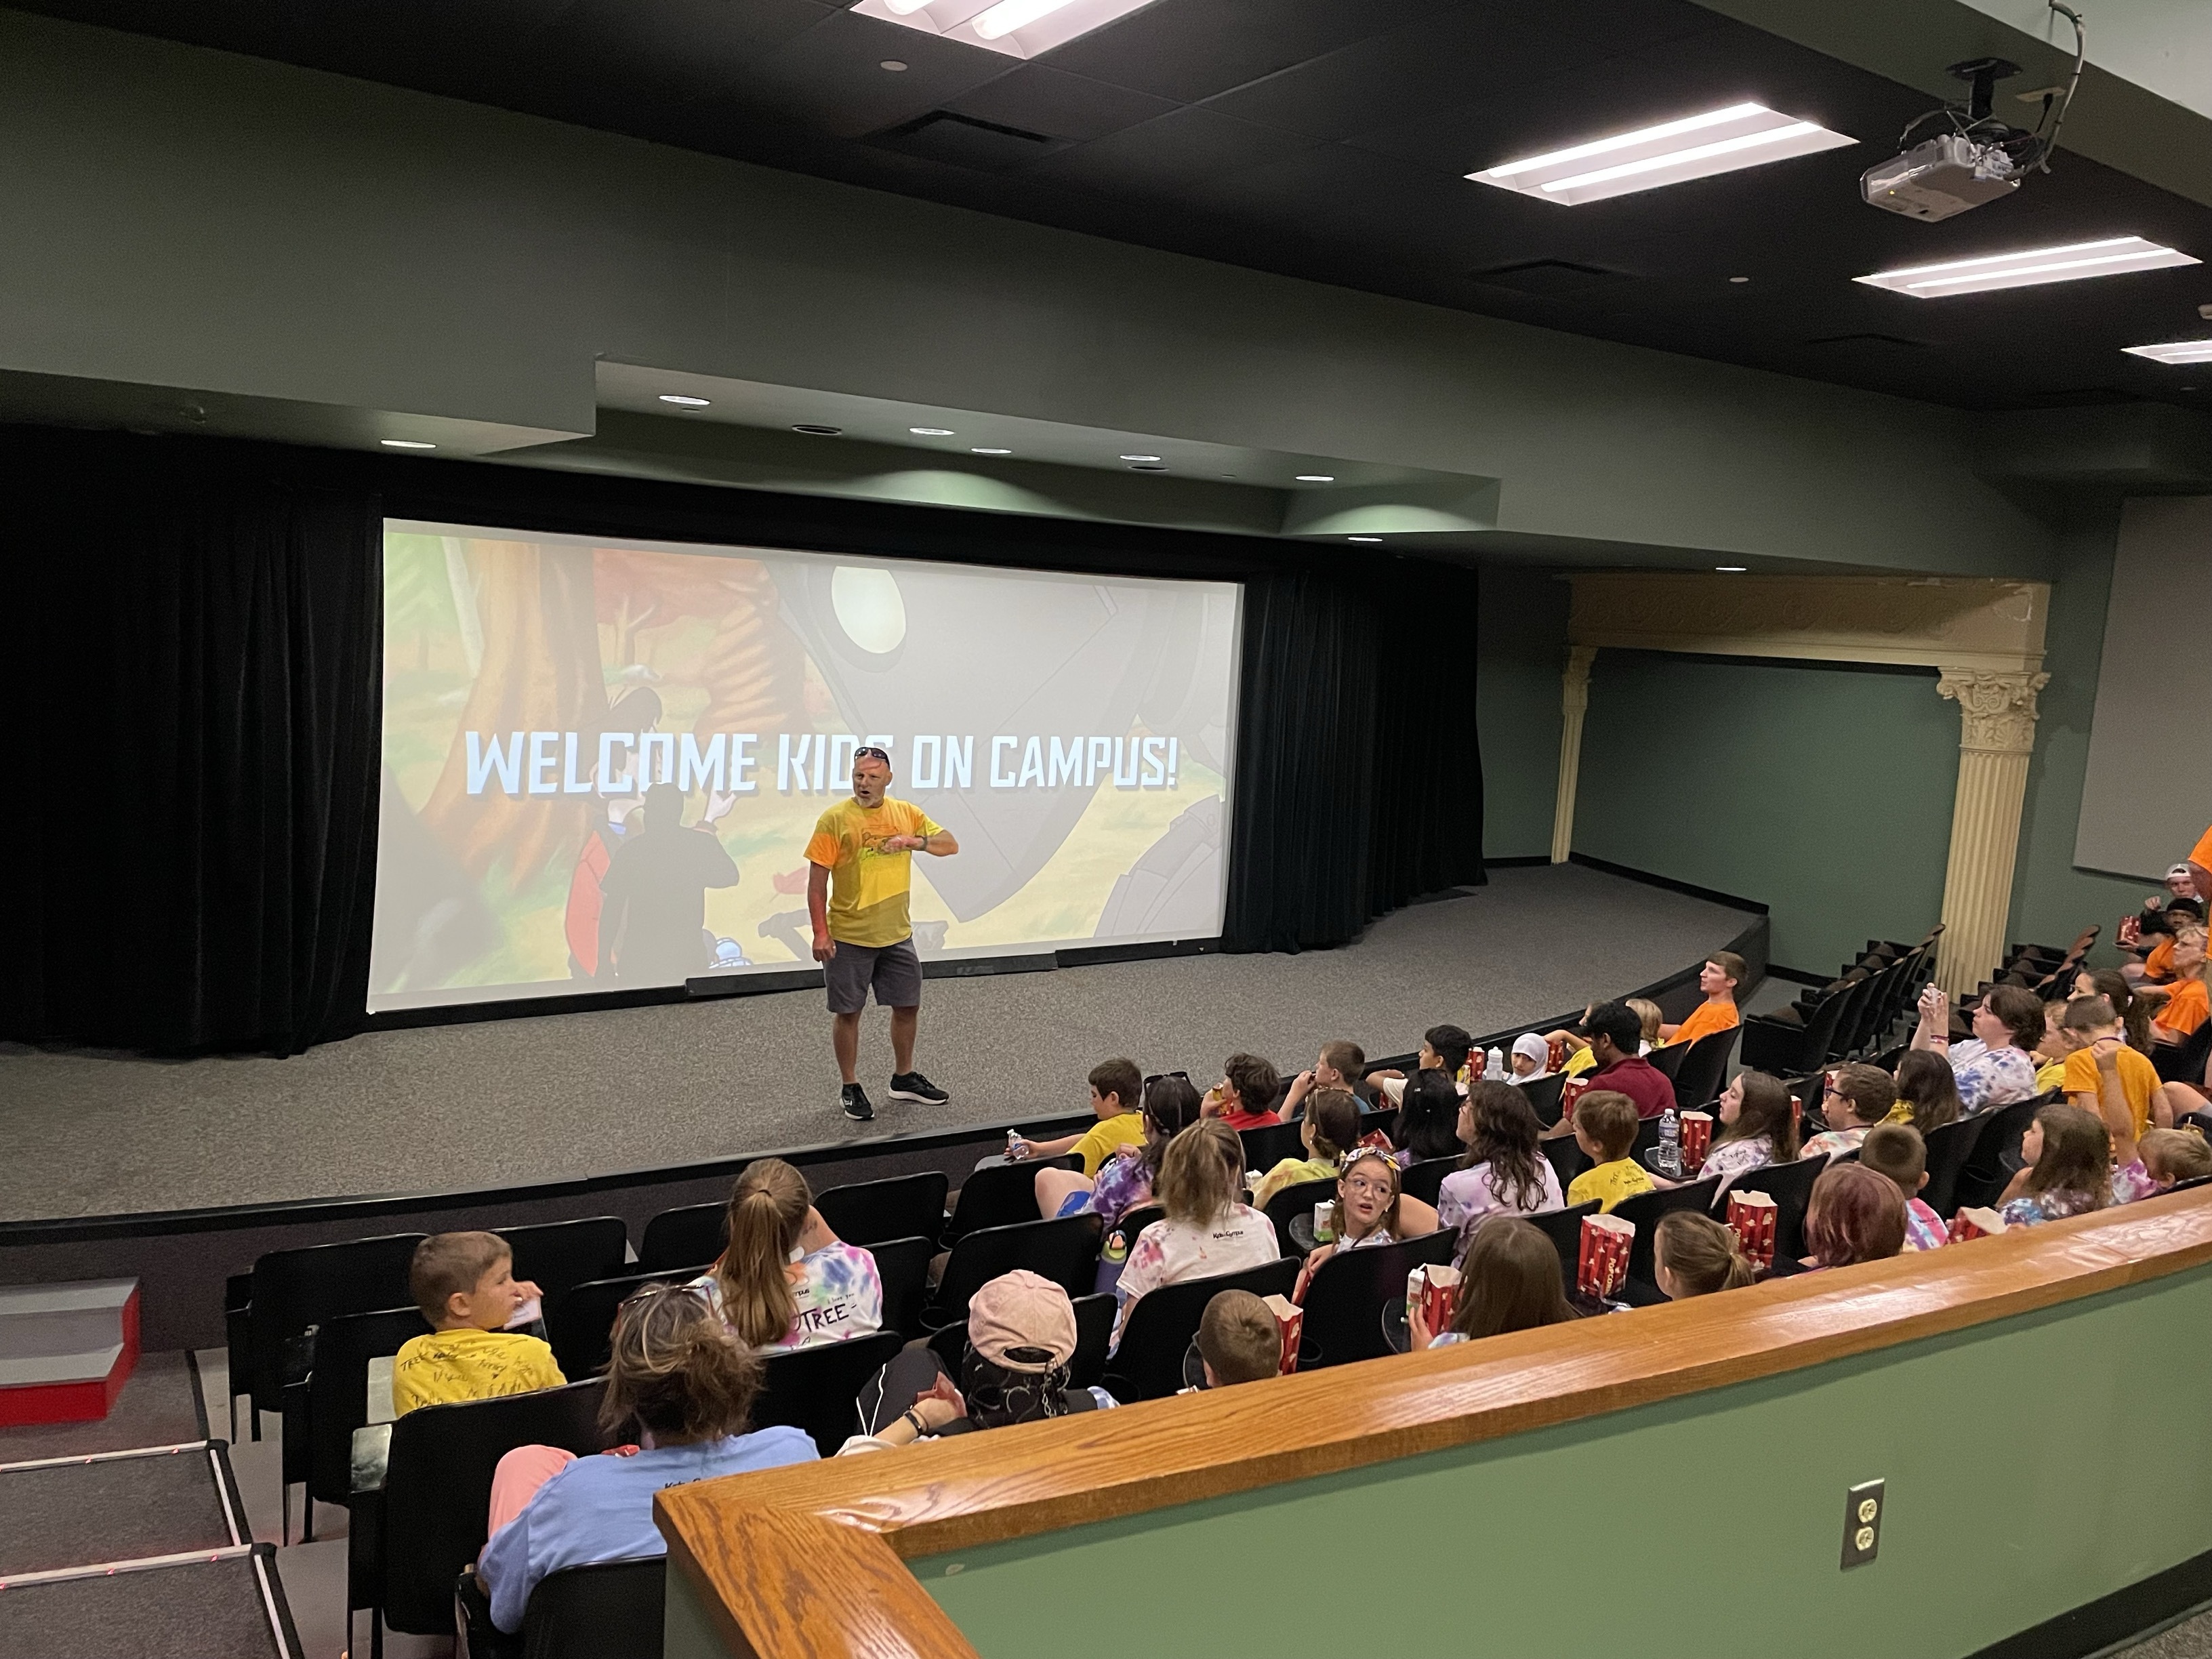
[392,1232,569,1416]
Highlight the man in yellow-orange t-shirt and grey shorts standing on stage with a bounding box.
[807,747,960,1124]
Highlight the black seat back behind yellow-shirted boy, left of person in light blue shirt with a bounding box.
[383,1378,613,1637]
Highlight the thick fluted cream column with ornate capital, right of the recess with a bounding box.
[1936,668,2051,996]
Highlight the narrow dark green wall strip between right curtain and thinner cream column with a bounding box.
[1475,564,1568,858]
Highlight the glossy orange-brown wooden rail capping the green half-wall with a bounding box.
[655,1190,2212,1659]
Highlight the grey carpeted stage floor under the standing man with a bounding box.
[0,865,1750,1221]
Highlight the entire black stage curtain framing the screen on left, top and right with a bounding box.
[0,427,1482,1053]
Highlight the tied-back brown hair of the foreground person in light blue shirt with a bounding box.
[600,1285,781,1447]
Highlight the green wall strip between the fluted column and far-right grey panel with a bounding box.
[2011,513,2150,964]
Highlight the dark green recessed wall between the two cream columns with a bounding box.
[1575,651,1958,973]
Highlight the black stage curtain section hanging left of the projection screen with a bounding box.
[0,429,383,1053]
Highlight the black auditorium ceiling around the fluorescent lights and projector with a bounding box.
[24,0,2212,409]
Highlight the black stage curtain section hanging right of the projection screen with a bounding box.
[1221,553,1484,951]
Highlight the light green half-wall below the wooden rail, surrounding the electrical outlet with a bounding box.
[914,1270,2212,1659]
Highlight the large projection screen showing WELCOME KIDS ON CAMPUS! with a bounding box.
[369,520,1241,1013]
